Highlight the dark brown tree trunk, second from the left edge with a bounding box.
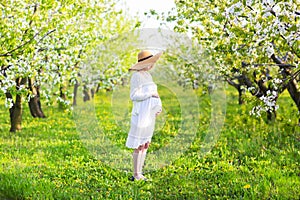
[28,78,46,118]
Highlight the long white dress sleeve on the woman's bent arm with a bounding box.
[130,72,152,101]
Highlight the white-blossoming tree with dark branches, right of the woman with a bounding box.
[167,0,300,123]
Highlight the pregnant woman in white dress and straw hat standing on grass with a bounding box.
[126,50,162,181]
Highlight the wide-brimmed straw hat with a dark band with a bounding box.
[130,50,162,70]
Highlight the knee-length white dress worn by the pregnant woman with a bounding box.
[126,71,162,149]
